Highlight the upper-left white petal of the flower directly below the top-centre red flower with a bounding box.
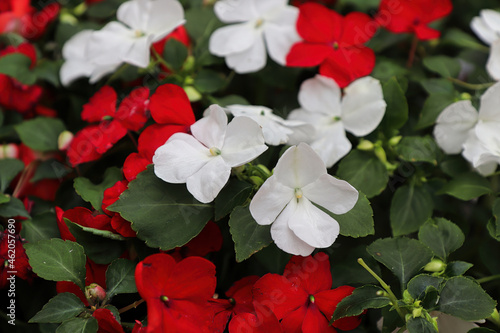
[299,74,341,117]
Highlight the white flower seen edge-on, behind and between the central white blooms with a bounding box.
[226,104,314,146]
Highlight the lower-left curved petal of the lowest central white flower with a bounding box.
[271,200,314,257]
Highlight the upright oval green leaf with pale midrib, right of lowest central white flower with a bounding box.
[390,185,434,236]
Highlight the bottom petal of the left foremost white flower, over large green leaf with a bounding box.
[186,156,231,203]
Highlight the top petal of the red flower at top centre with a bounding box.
[297,3,343,43]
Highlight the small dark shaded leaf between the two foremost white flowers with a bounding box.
[214,180,252,221]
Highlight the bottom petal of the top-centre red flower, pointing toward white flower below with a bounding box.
[319,47,375,88]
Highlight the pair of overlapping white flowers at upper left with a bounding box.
[60,0,184,86]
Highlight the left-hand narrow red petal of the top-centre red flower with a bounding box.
[286,43,333,67]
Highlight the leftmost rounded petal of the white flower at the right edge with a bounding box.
[434,101,478,154]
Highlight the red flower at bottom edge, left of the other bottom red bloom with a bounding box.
[135,253,216,333]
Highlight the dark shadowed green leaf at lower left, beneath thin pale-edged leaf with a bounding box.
[64,218,126,264]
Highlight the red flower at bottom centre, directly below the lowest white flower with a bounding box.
[253,253,360,333]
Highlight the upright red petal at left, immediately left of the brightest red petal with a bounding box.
[115,87,149,131]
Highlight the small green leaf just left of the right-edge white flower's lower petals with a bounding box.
[396,135,440,165]
